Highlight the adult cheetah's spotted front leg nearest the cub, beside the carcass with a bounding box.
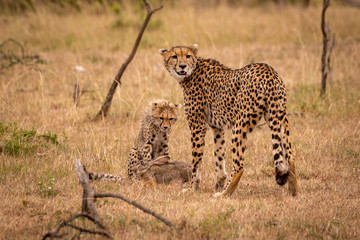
[183,128,206,192]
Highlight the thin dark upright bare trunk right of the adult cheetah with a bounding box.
[320,0,335,96]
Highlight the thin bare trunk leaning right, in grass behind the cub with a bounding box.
[94,0,163,120]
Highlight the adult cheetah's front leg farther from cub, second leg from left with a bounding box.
[213,128,228,191]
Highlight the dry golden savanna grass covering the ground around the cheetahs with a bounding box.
[0,1,360,239]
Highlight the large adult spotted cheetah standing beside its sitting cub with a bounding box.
[159,44,298,197]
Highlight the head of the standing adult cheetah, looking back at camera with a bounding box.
[159,44,199,83]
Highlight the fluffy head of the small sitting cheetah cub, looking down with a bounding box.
[150,100,180,131]
